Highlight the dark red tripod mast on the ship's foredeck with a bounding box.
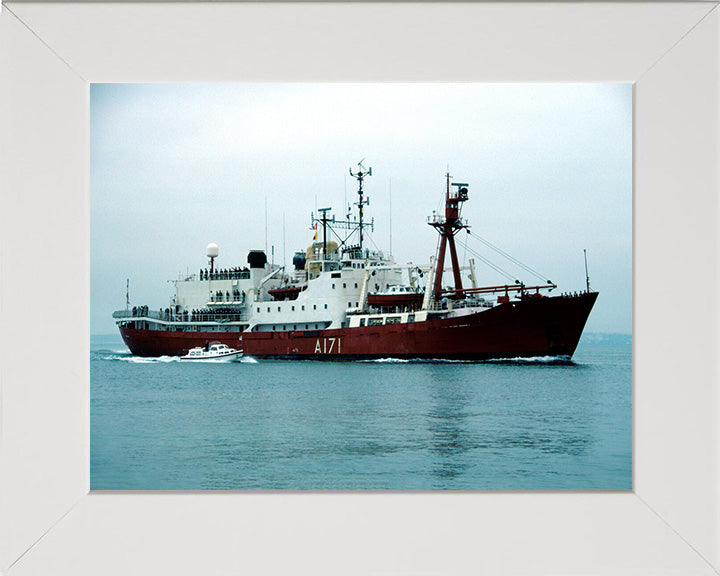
[428,172,468,298]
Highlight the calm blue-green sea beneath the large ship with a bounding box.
[90,335,632,490]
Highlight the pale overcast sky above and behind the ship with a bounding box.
[90,84,632,334]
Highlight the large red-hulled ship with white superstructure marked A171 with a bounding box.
[113,163,598,361]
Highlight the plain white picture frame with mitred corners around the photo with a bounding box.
[0,2,720,576]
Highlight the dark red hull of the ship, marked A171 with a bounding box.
[120,292,597,360]
